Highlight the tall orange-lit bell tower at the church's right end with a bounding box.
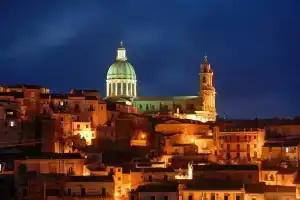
[199,54,216,120]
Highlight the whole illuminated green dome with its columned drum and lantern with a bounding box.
[106,42,137,97]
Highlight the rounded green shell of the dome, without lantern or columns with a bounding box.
[106,60,136,80]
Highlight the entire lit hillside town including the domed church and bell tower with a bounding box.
[0,42,300,200]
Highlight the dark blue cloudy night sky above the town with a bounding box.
[0,0,300,117]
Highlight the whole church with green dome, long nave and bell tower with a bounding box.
[106,42,217,122]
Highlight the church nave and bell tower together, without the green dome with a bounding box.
[134,56,217,122]
